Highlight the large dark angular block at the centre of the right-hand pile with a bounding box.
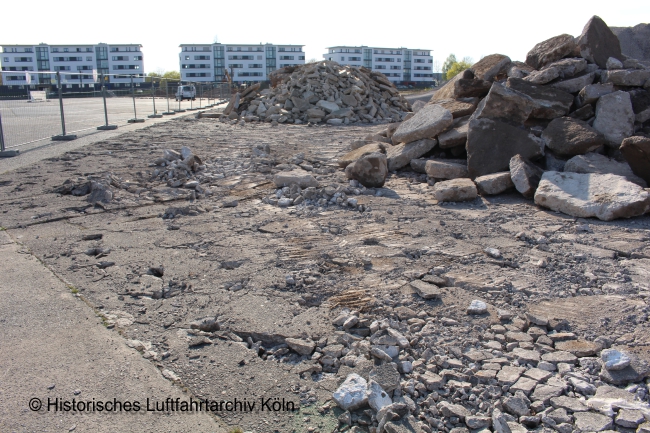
[467,119,544,178]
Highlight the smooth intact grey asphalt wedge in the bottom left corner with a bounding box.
[0,226,228,433]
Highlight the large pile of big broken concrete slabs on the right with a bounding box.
[341,16,650,220]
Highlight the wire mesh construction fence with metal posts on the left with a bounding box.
[0,71,230,156]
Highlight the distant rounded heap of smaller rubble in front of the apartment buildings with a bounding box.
[221,61,411,125]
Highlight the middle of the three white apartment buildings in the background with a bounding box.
[178,43,305,83]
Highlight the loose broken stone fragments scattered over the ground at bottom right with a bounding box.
[270,300,650,433]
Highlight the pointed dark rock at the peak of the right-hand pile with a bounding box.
[576,15,624,69]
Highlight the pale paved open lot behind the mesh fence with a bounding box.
[0,97,223,148]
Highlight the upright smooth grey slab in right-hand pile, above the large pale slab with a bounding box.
[594,90,634,148]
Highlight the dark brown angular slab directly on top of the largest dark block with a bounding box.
[472,83,535,125]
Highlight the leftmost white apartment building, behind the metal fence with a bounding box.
[0,43,145,88]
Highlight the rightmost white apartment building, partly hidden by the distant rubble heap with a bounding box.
[323,46,433,83]
